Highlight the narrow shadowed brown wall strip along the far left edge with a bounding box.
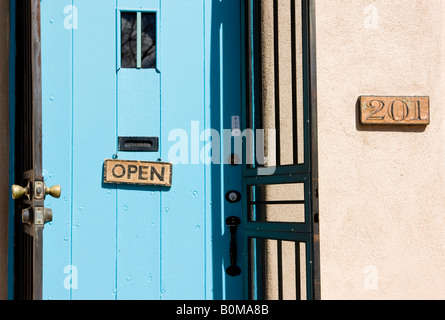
[0,1,9,299]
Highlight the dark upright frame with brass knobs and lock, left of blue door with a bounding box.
[10,0,45,300]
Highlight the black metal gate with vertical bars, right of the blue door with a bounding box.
[243,0,320,300]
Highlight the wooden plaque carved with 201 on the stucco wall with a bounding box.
[360,96,430,126]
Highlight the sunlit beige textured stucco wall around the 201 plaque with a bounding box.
[316,0,445,299]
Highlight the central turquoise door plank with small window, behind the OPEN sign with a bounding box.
[116,0,161,299]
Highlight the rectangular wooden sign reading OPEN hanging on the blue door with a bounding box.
[103,159,173,187]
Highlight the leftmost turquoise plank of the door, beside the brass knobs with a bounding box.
[41,1,73,299]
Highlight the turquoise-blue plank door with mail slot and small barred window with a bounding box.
[41,0,244,299]
